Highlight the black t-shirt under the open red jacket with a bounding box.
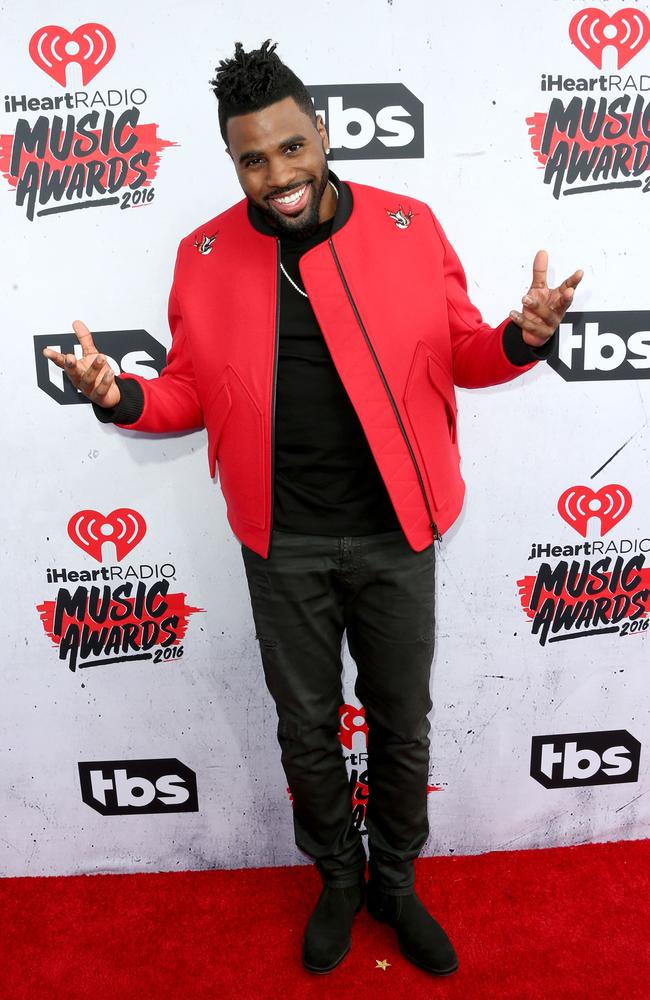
[273,219,400,535]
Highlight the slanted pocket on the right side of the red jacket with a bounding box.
[403,341,460,510]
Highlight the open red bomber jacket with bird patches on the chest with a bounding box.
[114,181,537,558]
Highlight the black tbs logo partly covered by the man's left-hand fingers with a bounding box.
[34,330,167,406]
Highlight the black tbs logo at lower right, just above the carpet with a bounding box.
[530,729,641,788]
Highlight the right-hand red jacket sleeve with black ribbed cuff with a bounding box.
[431,212,552,389]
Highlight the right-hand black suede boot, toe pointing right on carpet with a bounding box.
[366,879,458,976]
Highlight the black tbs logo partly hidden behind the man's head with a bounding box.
[309,83,424,160]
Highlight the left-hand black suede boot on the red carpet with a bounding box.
[302,880,365,972]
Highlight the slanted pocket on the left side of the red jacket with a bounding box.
[208,365,267,528]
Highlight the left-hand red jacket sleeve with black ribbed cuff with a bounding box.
[93,249,204,433]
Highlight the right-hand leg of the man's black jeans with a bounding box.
[345,532,435,895]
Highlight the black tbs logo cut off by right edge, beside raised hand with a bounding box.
[548,311,650,382]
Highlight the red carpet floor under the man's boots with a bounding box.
[0,840,650,1000]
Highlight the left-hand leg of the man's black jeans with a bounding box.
[242,531,366,886]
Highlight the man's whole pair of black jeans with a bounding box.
[242,530,435,895]
